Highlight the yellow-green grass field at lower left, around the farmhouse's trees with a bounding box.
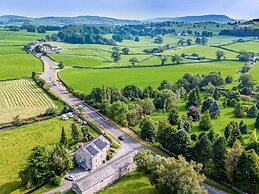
[0,118,99,193]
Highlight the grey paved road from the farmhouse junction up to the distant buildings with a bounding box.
[41,56,228,194]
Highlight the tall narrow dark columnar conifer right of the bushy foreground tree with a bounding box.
[212,137,228,180]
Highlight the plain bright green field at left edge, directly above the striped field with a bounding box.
[0,54,43,81]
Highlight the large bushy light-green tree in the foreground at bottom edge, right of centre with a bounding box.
[150,156,207,194]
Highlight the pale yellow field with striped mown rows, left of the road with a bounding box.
[0,79,56,123]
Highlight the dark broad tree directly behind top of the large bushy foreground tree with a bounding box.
[169,129,191,156]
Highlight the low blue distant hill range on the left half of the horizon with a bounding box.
[0,15,142,26]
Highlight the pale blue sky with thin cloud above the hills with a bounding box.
[0,0,259,20]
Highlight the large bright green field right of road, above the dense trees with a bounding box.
[60,61,243,93]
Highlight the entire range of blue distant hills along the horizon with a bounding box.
[0,15,241,26]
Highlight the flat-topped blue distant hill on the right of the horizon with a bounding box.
[147,15,236,23]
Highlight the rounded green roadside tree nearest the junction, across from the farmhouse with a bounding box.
[140,116,158,142]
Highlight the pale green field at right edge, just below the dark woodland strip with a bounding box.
[224,41,259,53]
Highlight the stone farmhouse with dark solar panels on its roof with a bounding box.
[75,135,111,170]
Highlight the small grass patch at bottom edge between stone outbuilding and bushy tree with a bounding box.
[100,172,158,194]
